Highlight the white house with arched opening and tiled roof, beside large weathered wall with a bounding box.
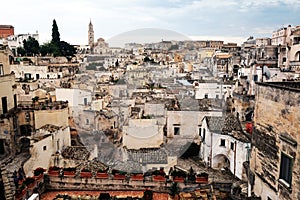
[199,114,251,180]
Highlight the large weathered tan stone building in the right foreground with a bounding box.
[249,82,300,200]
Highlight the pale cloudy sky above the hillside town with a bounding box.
[0,0,300,45]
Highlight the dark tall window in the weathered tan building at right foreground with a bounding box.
[279,153,293,187]
